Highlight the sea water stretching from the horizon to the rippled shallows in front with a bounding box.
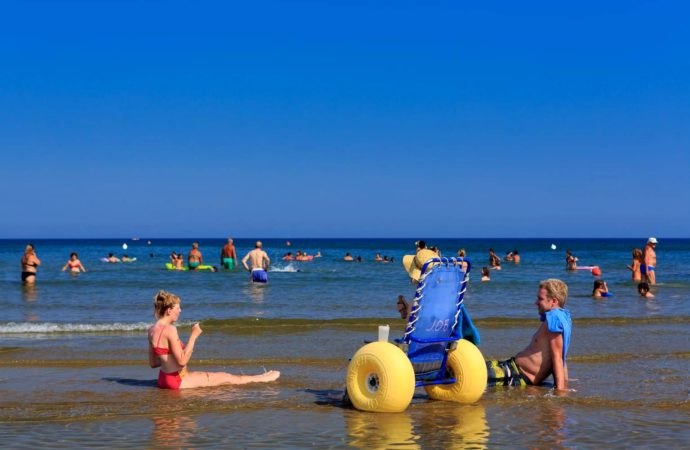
[0,239,690,449]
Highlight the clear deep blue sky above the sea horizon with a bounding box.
[0,0,690,238]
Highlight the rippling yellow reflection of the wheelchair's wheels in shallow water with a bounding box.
[345,402,489,449]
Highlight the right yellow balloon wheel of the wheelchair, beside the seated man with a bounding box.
[424,339,486,403]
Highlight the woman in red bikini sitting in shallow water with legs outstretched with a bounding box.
[148,291,280,389]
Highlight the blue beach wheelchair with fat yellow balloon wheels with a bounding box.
[346,258,487,412]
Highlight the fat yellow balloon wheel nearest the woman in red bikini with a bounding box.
[345,342,414,412]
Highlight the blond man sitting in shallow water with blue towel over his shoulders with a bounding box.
[486,278,573,390]
